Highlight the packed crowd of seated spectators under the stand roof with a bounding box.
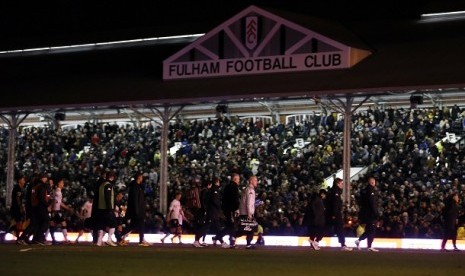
[0,103,465,238]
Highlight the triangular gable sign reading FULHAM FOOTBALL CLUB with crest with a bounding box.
[163,6,366,80]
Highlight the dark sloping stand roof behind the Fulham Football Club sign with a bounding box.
[0,4,465,112]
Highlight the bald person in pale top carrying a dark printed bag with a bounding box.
[238,175,258,249]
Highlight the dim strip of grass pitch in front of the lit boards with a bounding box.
[0,244,465,276]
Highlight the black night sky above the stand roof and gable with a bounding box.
[0,0,442,50]
